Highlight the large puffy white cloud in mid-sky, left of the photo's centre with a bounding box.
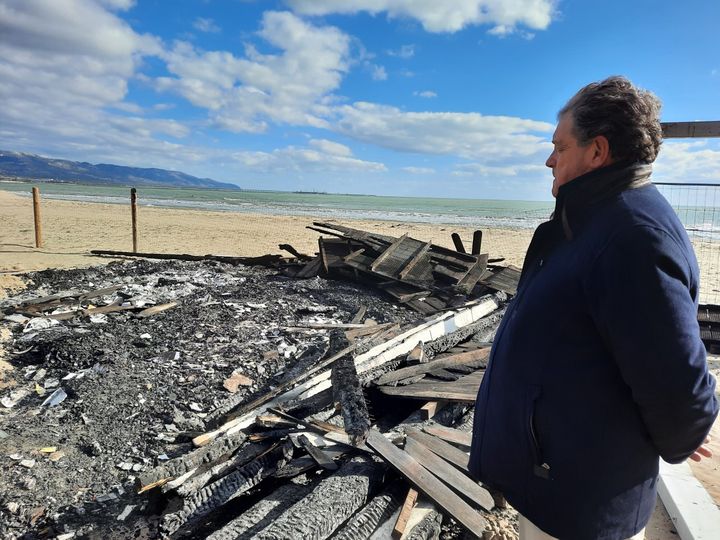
[156,12,350,133]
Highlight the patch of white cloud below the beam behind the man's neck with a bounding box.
[653,140,720,183]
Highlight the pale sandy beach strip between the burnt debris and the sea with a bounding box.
[0,191,532,273]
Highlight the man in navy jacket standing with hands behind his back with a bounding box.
[470,77,718,540]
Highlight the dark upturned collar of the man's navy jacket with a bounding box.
[553,162,652,240]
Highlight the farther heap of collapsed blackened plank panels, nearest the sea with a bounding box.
[288,222,520,315]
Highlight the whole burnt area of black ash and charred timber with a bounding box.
[0,224,517,539]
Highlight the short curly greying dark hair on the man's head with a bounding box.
[558,76,662,163]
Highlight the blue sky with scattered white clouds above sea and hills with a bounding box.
[0,0,720,200]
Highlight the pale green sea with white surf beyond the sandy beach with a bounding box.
[0,181,720,237]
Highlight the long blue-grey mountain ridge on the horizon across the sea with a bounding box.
[0,150,240,189]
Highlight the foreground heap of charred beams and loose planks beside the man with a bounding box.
[118,294,506,539]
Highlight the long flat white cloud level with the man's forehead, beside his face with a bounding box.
[335,102,554,159]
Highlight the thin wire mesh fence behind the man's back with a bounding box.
[655,182,720,304]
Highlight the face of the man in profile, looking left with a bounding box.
[545,113,597,197]
